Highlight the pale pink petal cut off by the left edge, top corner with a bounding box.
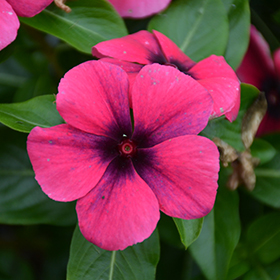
[0,0,19,51]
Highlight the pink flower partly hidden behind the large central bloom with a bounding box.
[92,30,240,121]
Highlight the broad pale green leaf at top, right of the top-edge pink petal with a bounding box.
[148,0,228,61]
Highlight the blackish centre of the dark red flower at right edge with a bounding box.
[261,77,280,120]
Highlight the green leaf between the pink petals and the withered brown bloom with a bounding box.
[201,84,259,151]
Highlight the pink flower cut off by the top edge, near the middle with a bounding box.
[108,0,171,18]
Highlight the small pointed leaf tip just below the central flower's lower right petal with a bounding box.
[173,218,203,249]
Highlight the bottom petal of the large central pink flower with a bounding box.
[76,158,159,251]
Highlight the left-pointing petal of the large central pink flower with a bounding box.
[27,124,118,201]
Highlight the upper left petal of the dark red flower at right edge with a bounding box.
[236,25,274,89]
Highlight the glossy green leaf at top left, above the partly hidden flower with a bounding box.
[20,0,127,54]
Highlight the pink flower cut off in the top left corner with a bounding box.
[0,0,53,50]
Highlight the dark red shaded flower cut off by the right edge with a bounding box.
[236,26,280,136]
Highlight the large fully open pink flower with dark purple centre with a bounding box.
[27,61,219,250]
